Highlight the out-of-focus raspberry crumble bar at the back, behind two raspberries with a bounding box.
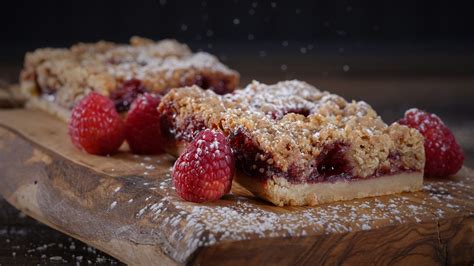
[20,37,239,119]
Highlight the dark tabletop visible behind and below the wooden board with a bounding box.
[0,56,474,265]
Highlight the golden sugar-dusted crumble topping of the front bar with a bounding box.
[159,80,424,178]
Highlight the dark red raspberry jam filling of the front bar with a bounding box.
[161,112,414,184]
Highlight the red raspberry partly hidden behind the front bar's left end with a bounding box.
[125,93,165,154]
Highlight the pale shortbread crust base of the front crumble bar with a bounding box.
[235,172,423,206]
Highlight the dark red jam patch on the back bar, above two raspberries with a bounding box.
[109,79,148,112]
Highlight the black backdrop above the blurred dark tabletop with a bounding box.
[0,0,474,64]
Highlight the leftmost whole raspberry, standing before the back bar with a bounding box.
[68,92,125,155]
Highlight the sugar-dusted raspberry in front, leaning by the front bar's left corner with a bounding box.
[172,129,234,202]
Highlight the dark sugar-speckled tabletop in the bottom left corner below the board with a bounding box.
[0,198,119,265]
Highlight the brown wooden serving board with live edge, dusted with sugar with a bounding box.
[0,109,474,265]
